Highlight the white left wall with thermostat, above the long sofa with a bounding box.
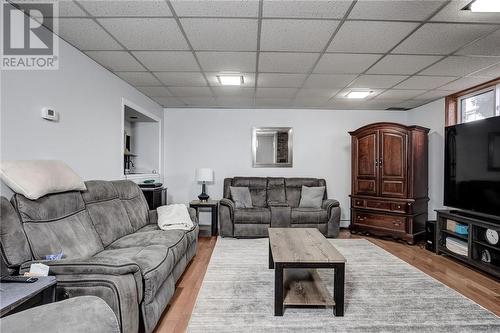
[0,30,163,196]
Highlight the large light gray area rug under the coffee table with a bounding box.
[188,238,500,333]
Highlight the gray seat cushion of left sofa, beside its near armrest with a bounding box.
[96,245,175,303]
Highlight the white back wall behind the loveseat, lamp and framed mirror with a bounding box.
[164,109,407,226]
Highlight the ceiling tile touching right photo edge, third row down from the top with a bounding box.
[420,56,500,76]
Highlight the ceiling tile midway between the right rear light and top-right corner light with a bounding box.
[367,54,442,75]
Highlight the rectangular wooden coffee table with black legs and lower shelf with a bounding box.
[269,228,346,316]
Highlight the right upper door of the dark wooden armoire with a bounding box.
[379,130,408,198]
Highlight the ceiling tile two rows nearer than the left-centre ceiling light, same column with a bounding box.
[181,18,257,51]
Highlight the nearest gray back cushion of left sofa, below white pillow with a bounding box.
[12,192,103,260]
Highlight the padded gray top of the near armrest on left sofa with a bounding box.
[19,257,141,279]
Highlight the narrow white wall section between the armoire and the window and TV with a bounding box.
[408,98,445,220]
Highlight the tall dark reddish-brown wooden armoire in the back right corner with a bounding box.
[349,123,429,244]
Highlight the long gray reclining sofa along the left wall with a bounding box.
[0,181,199,333]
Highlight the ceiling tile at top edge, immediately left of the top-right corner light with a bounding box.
[349,0,445,20]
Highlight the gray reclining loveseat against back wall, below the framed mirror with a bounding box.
[219,177,340,237]
